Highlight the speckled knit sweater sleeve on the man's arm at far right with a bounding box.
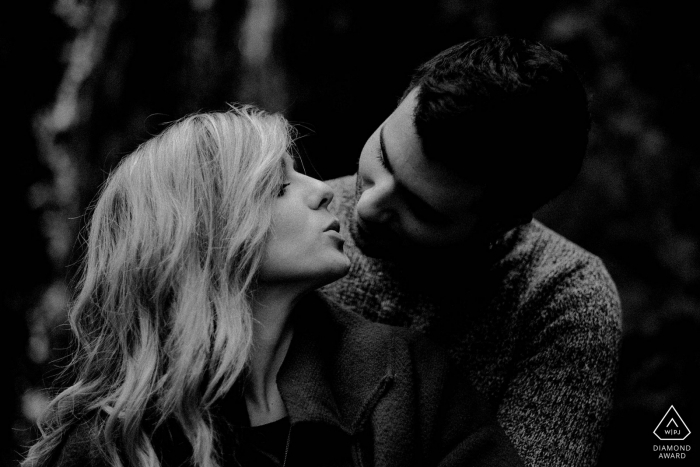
[498,257,620,466]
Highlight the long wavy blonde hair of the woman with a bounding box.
[22,106,291,467]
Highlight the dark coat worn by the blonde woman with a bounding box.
[49,294,522,467]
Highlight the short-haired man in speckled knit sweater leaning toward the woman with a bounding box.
[324,37,620,466]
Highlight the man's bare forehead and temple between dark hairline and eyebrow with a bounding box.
[382,90,482,210]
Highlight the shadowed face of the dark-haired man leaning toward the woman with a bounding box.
[353,89,483,257]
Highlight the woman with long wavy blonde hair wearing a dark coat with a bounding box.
[23,107,517,467]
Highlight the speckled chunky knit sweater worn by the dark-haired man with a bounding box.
[322,176,621,466]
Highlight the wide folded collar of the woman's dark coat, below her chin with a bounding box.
[277,292,395,435]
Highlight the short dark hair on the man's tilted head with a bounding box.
[406,36,590,213]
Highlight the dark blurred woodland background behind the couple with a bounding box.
[0,0,700,466]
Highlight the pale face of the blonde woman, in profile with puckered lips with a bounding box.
[260,155,350,289]
